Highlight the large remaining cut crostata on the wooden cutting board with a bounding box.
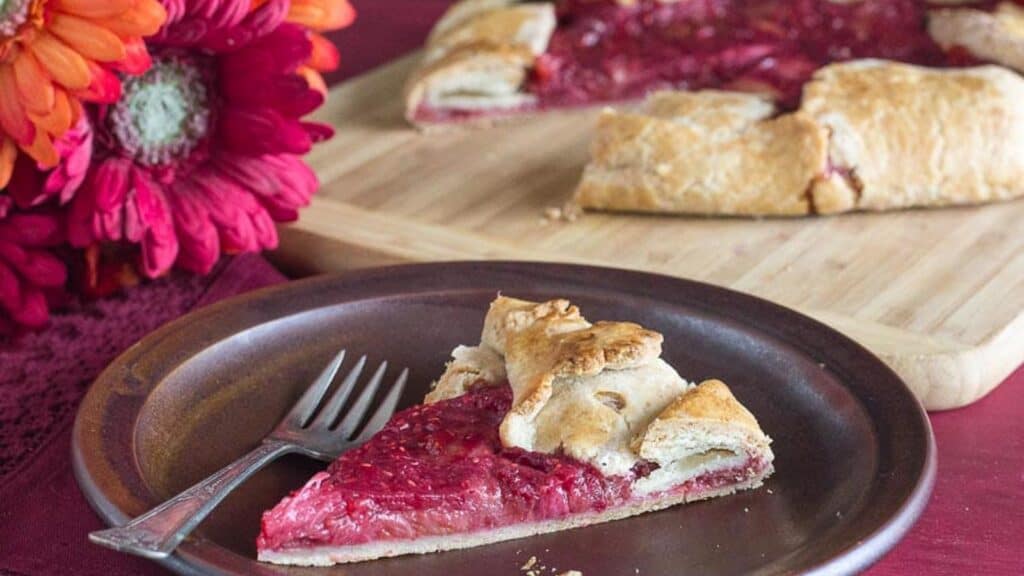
[407,0,1024,215]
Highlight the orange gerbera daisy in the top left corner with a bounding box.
[0,0,167,188]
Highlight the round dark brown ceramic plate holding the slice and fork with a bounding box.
[74,262,935,576]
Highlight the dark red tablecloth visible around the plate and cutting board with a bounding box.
[0,0,1024,576]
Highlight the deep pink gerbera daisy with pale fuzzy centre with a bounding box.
[69,0,331,278]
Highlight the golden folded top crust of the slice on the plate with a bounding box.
[426,296,772,477]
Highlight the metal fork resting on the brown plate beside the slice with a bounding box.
[89,351,409,559]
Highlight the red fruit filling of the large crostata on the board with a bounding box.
[416,0,1024,121]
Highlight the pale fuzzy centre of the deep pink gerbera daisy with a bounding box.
[111,56,210,166]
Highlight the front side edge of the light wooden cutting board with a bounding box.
[273,199,1024,410]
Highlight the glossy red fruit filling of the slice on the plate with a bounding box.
[257,384,769,551]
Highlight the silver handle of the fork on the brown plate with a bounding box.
[89,441,295,559]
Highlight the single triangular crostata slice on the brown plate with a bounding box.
[257,296,773,565]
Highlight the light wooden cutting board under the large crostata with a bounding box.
[276,54,1024,409]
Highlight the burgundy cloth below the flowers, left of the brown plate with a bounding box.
[0,255,285,576]
